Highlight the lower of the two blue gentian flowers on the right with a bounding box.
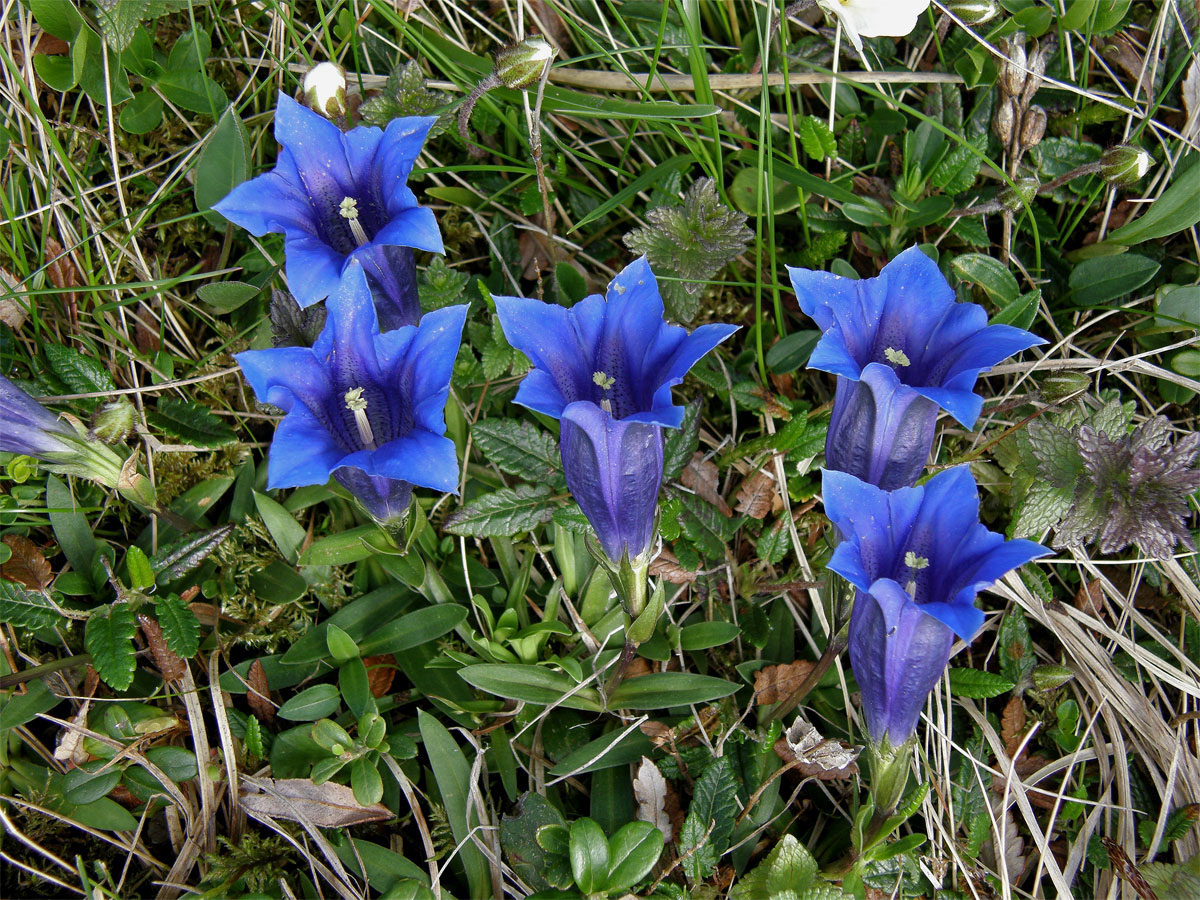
[822,466,1050,746]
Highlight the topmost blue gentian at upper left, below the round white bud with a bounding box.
[212,94,443,331]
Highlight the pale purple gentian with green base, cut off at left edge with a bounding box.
[0,376,155,506]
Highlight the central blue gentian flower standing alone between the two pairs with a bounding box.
[496,257,737,562]
